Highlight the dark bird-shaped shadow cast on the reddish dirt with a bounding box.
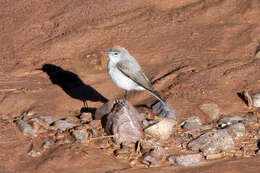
[40,64,108,113]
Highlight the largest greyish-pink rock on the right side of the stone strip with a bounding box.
[188,129,235,155]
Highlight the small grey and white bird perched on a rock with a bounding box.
[105,46,166,103]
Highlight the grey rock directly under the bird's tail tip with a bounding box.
[152,101,178,121]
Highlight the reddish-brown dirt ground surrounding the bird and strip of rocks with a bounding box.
[0,0,260,173]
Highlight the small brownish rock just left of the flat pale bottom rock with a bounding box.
[144,147,165,164]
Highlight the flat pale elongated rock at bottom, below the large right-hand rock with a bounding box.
[168,154,203,166]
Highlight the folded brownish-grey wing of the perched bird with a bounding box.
[116,63,153,91]
